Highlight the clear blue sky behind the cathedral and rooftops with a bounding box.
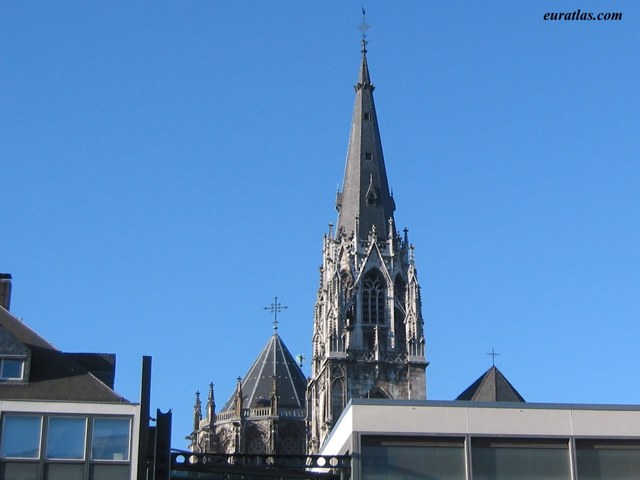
[0,0,640,447]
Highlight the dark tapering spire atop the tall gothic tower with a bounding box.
[336,36,395,239]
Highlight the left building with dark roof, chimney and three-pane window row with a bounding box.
[0,274,140,480]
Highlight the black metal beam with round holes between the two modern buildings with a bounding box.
[171,450,351,480]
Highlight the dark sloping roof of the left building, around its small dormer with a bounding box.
[0,306,129,403]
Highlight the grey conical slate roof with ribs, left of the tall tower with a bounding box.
[221,333,307,412]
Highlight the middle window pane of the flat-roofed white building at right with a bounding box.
[471,439,571,480]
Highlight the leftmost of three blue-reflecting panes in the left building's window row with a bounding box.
[0,415,42,458]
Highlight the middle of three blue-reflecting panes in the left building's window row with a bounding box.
[47,417,87,460]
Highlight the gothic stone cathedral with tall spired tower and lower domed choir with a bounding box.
[188,36,428,454]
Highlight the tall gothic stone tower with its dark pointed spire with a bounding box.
[307,35,427,453]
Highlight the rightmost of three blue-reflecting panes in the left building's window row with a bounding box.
[91,418,131,461]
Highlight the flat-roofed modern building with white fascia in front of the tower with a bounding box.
[321,399,640,480]
